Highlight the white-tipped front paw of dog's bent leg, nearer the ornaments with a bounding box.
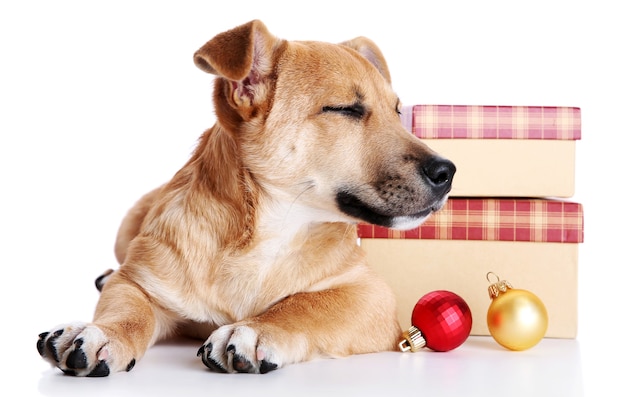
[198,325,282,374]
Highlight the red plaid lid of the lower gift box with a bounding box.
[357,198,583,243]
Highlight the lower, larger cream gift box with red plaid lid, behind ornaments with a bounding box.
[358,198,583,338]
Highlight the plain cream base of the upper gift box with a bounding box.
[422,139,576,197]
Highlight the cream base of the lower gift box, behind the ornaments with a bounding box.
[361,238,578,338]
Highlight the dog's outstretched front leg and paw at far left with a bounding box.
[37,273,164,377]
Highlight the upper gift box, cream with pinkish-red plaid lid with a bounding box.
[402,105,581,198]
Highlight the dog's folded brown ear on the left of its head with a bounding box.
[193,20,280,105]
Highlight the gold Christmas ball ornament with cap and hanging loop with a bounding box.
[487,272,548,350]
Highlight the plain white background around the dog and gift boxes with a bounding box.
[0,0,626,395]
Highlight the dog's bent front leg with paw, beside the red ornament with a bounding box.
[198,270,401,373]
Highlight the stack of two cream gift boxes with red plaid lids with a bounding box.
[358,105,583,338]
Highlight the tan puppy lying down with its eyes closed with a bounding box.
[37,20,456,377]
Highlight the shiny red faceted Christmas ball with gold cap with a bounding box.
[398,290,472,352]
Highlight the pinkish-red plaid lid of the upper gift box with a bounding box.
[401,105,581,140]
